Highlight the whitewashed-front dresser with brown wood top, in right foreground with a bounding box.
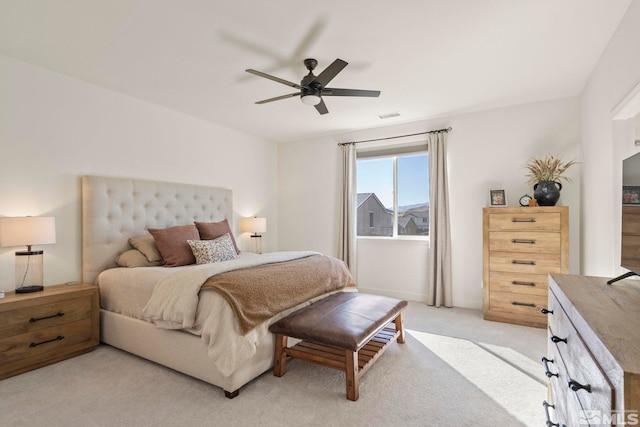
[542,274,640,427]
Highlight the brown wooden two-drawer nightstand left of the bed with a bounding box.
[0,284,100,379]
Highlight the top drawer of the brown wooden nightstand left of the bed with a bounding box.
[0,295,92,337]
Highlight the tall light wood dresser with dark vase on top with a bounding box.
[482,206,569,328]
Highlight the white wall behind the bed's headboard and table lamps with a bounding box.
[0,56,278,290]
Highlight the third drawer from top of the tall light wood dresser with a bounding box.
[489,251,562,274]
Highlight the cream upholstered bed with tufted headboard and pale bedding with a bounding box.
[82,176,355,398]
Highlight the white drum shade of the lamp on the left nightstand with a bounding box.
[0,216,56,246]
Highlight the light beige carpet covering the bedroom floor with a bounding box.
[0,302,546,427]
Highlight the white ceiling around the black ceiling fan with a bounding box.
[0,0,631,141]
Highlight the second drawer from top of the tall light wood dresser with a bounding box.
[489,231,560,254]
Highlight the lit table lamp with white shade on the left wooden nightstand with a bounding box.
[0,216,56,294]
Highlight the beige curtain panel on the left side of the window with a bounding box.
[338,144,357,278]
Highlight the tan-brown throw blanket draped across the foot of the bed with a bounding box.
[201,255,355,335]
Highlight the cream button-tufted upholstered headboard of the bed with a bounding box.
[82,176,233,283]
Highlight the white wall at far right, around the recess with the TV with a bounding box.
[581,1,640,277]
